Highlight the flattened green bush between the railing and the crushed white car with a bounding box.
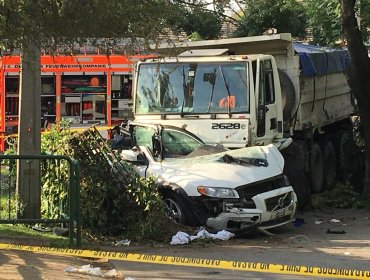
[42,124,168,242]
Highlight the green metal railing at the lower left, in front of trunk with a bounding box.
[0,155,81,246]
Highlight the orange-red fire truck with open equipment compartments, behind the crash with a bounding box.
[0,51,147,150]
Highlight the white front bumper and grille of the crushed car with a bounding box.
[206,186,297,231]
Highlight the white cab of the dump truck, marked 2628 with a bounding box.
[134,50,283,151]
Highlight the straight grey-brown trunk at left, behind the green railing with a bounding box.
[17,39,41,219]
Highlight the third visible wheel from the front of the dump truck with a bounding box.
[321,141,337,189]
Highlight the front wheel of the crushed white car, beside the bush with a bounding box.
[164,193,193,225]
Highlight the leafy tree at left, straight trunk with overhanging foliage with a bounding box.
[0,0,181,218]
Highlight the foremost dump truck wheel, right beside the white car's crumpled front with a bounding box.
[284,157,310,210]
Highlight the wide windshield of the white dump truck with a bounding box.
[135,62,249,114]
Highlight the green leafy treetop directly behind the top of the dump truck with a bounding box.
[234,0,306,38]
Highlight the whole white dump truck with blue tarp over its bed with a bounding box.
[133,34,354,207]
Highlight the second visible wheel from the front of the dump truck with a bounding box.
[308,143,324,193]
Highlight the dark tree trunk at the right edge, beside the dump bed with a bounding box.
[341,0,370,198]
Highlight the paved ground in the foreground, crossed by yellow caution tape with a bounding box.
[0,209,370,280]
